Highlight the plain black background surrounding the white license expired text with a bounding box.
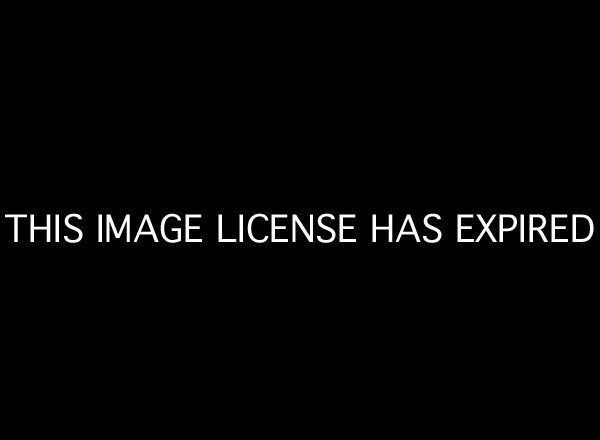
[1,5,598,433]
